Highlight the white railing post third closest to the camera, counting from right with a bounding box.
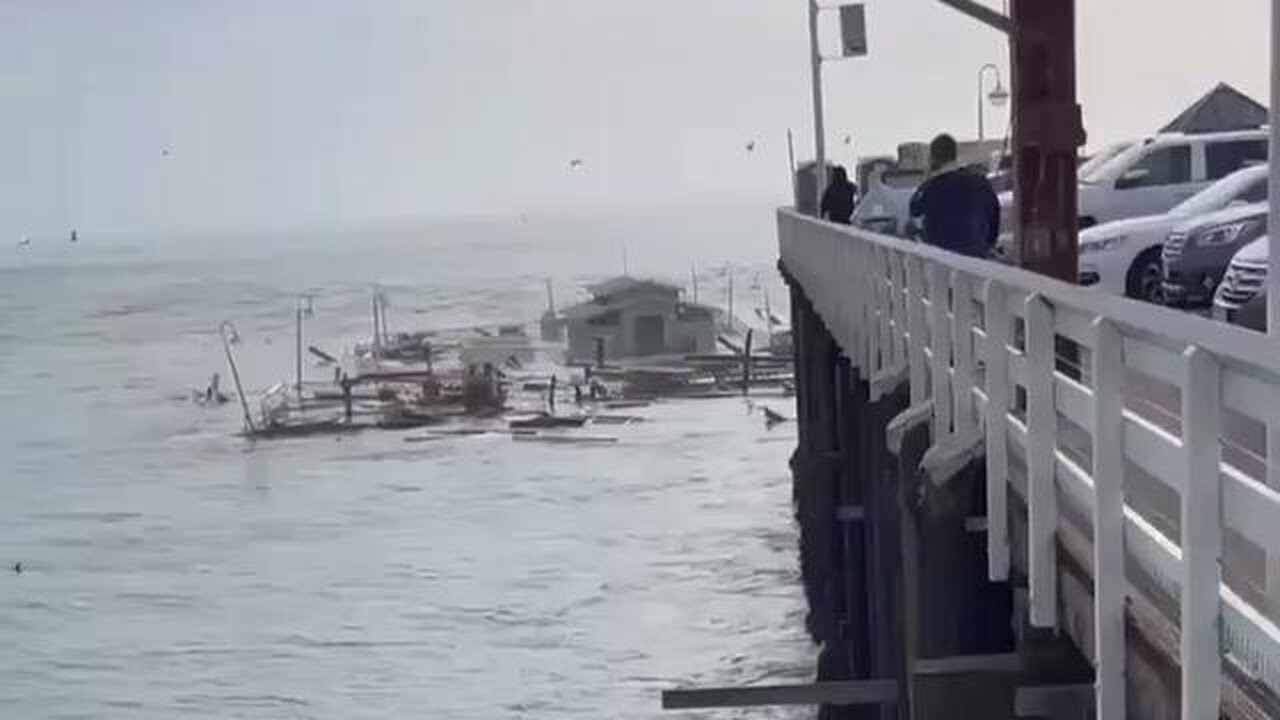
[1025,295,1057,628]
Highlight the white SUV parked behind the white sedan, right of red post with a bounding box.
[1000,128,1268,242]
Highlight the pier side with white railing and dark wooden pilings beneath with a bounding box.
[778,210,1280,719]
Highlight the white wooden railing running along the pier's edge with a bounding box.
[778,210,1280,720]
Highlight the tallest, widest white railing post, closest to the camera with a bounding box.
[1180,346,1222,719]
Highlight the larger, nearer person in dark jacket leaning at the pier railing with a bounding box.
[910,135,1000,258]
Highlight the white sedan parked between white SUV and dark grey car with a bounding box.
[1080,165,1267,302]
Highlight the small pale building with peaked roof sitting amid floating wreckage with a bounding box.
[563,275,718,363]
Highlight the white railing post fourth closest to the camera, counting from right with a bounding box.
[982,281,1009,582]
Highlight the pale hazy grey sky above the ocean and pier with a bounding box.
[0,0,1268,238]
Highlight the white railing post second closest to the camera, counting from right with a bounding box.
[1092,318,1128,720]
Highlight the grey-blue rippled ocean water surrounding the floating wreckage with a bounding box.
[0,210,813,719]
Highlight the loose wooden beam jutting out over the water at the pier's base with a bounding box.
[662,680,897,710]
